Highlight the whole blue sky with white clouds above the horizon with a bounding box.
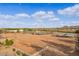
[0,3,79,28]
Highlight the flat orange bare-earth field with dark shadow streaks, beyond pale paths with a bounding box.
[2,33,75,55]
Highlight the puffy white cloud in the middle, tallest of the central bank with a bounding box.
[32,11,59,21]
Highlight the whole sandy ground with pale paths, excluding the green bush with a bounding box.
[0,27,77,56]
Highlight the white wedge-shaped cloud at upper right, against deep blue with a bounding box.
[58,4,79,16]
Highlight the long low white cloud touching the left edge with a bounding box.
[0,13,30,21]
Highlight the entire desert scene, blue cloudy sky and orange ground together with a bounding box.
[0,3,79,56]
